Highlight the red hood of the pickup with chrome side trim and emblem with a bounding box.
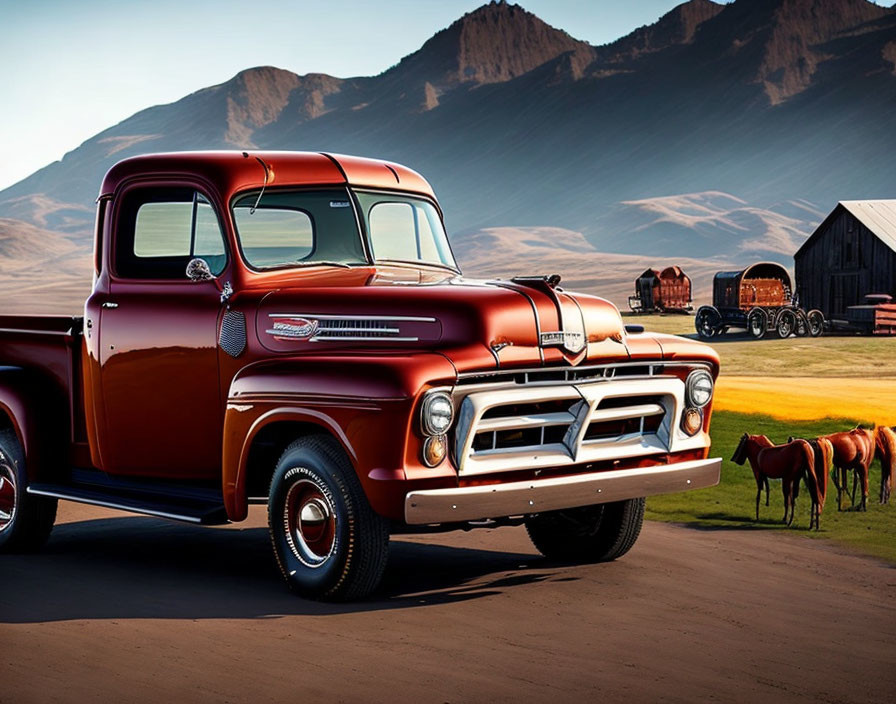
[256,270,702,372]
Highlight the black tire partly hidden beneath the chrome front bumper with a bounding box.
[526,499,644,562]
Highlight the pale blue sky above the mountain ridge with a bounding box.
[0,0,888,188]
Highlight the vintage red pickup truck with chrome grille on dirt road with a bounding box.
[0,152,721,599]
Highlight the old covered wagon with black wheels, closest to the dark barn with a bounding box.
[694,262,824,339]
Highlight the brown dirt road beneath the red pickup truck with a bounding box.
[0,504,896,704]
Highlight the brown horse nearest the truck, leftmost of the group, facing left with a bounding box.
[731,433,818,525]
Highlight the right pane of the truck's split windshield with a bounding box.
[355,191,457,269]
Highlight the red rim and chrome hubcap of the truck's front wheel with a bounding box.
[283,479,336,567]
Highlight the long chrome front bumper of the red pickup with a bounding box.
[404,457,722,525]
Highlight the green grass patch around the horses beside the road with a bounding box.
[647,411,896,564]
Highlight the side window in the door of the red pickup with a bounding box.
[115,188,227,280]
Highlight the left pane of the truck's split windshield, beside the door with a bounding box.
[233,188,367,269]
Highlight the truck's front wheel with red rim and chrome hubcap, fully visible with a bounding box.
[268,435,389,601]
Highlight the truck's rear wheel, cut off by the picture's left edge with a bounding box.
[0,430,57,552]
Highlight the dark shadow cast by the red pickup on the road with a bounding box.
[0,517,575,623]
